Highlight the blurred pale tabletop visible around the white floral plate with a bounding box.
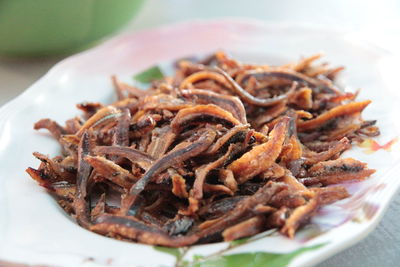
[0,0,400,267]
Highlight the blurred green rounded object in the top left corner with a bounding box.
[0,0,144,56]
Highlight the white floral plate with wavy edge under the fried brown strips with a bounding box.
[0,20,400,266]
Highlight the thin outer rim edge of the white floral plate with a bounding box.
[0,18,400,266]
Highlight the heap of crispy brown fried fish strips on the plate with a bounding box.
[27,52,379,247]
